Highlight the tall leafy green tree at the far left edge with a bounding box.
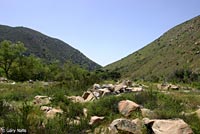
[0,40,26,78]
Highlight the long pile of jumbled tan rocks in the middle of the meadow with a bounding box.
[67,80,144,103]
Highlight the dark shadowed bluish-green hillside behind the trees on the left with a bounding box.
[0,25,100,70]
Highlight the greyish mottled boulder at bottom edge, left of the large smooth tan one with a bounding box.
[109,118,142,134]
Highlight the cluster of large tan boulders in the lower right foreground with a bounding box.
[108,100,193,134]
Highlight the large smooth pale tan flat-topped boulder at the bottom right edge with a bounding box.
[144,119,193,134]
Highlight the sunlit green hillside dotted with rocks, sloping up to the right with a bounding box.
[105,16,200,79]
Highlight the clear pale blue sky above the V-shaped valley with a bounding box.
[0,0,200,65]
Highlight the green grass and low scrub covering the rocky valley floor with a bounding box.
[0,82,200,133]
